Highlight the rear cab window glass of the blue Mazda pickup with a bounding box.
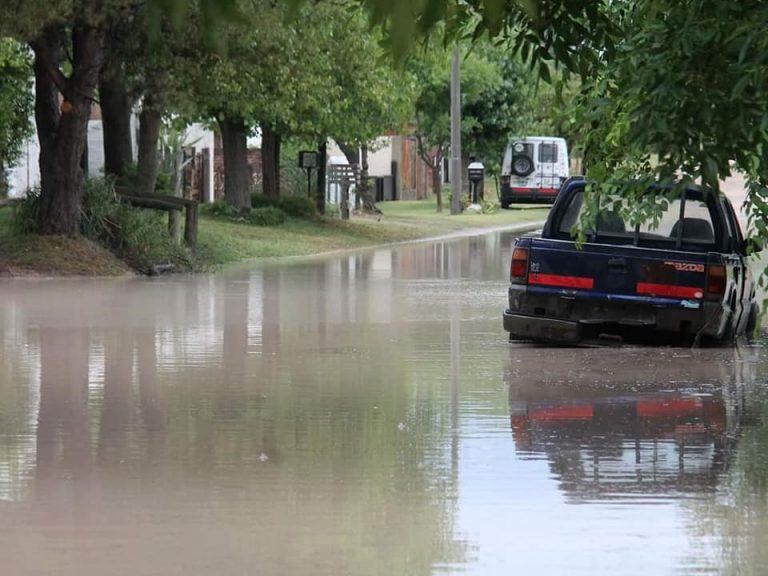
[557,190,717,250]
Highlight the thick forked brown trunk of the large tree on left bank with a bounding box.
[32,21,102,236]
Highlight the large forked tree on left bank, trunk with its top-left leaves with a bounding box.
[0,0,103,235]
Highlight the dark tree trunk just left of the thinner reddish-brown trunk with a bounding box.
[219,118,252,210]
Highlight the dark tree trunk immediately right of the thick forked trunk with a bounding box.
[99,53,133,178]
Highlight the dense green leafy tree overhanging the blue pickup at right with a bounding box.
[573,0,768,237]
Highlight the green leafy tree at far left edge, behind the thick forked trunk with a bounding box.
[0,38,33,196]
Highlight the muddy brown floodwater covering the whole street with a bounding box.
[0,233,768,576]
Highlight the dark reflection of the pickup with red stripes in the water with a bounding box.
[507,346,748,500]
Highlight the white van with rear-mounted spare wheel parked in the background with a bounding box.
[501,136,569,208]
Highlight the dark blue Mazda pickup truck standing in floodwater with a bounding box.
[504,180,758,344]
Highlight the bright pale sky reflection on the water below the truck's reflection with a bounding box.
[457,434,688,575]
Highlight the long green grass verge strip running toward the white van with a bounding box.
[199,200,548,264]
